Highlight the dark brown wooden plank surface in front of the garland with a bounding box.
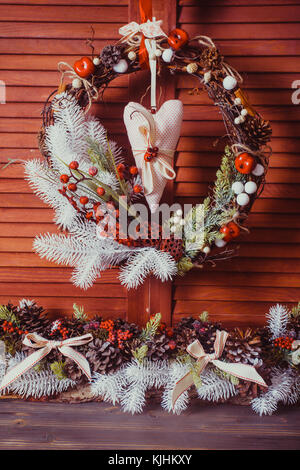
[0,400,300,450]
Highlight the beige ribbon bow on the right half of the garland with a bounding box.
[172,330,267,408]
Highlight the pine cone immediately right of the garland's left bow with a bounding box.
[86,338,126,374]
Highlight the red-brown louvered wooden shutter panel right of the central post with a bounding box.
[173,0,300,325]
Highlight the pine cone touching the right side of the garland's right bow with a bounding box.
[224,328,263,367]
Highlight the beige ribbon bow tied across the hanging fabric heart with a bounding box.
[132,103,176,196]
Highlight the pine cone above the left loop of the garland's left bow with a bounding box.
[13,301,51,336]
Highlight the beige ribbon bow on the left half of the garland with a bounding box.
[0,333,93,391]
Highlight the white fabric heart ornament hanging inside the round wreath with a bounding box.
[124,100,183,212]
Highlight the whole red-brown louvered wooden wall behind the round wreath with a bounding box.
[0,0,300,324]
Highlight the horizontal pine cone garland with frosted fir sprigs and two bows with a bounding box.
[0,299,300,415]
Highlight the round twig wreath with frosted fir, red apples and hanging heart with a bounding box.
[15,2,271,288]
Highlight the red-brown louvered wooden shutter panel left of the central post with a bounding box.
[0,0,128,318]
